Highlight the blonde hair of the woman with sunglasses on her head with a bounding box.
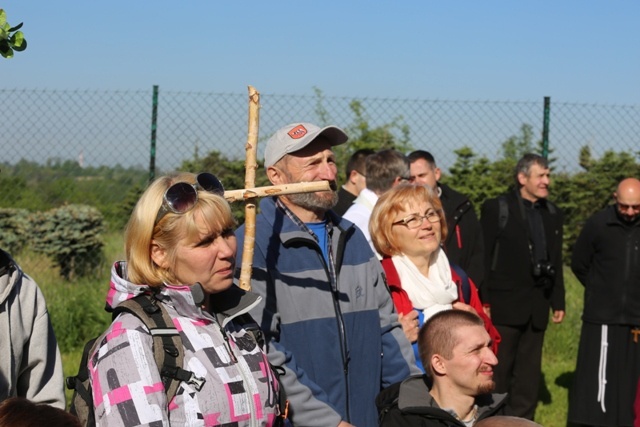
[124,172,236,287]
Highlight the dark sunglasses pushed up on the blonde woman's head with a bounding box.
[154,172,224,225]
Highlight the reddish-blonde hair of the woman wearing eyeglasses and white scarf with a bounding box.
[369,184,447,256]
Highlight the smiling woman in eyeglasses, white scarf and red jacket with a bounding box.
[369,184,500,370]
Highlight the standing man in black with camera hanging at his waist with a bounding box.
[480,154,565,419]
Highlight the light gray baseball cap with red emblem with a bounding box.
[264,123,349,168]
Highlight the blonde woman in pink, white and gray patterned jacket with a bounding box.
[88,173,279,427]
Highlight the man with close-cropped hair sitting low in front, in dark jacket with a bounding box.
[376,310,505,427]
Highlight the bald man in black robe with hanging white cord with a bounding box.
[569,178,640,426]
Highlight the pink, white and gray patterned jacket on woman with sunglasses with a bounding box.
[88,262,278,427]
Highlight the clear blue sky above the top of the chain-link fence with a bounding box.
[0,0,640,105]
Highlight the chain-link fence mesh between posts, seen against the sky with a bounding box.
[0,88,640,280]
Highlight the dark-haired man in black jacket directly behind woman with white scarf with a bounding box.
[407,150,484,287]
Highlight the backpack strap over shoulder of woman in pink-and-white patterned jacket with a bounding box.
[113,294,206,403]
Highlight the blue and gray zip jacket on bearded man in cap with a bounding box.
[237,198,420,427]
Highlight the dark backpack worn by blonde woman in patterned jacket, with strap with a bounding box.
[66,294,206,426]
